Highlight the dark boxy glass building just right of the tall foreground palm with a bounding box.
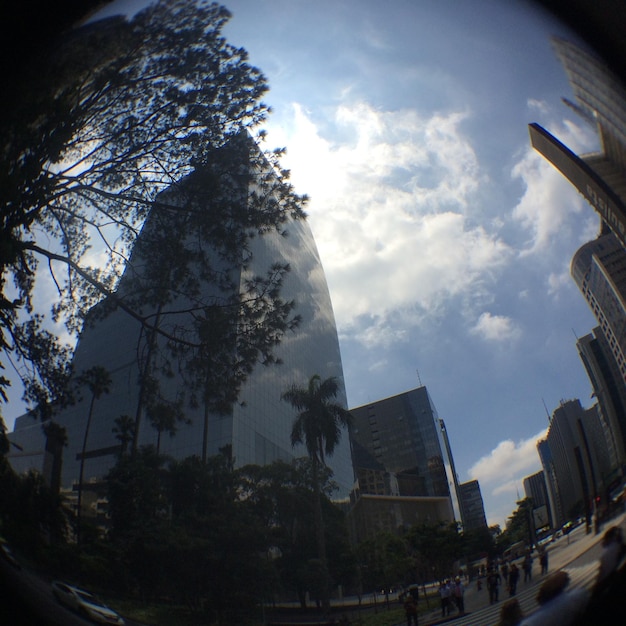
[350,386,458,542]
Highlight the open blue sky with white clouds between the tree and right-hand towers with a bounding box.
[5,0,599,527]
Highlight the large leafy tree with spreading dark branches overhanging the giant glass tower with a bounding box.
[0,0,306,424]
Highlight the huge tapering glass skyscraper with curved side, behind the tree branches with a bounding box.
[11,138,354,499]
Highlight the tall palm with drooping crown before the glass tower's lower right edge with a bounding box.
[281,374,352,612]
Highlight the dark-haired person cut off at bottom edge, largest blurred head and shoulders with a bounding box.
[520,570,597,626]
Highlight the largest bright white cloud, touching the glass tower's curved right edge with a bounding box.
[269,102,511,345]
